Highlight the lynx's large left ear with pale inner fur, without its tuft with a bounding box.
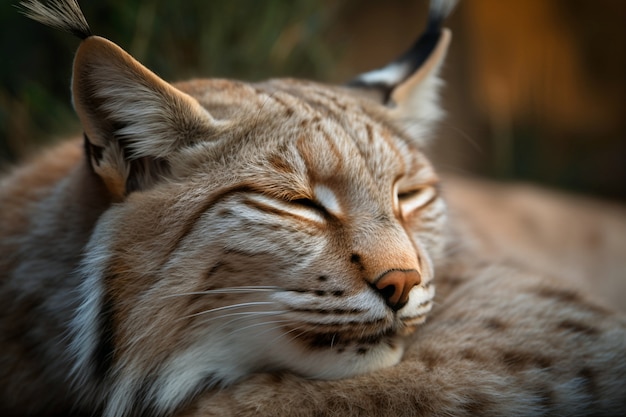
[72,36,215,199]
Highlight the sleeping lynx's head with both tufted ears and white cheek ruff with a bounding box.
[25,0,450,416]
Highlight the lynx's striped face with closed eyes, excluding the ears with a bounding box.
[76,81,444,412]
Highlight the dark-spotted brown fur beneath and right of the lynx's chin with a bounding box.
[180,255,626,417]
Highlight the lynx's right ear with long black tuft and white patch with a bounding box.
[348,0,457,140]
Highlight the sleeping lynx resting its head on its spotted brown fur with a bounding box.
[0,0,626,417]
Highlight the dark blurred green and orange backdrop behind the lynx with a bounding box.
[0,0,626,202]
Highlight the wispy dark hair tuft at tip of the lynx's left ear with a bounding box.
[20,0,91,39]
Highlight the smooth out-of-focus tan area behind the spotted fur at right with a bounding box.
[445,177,626,312]
